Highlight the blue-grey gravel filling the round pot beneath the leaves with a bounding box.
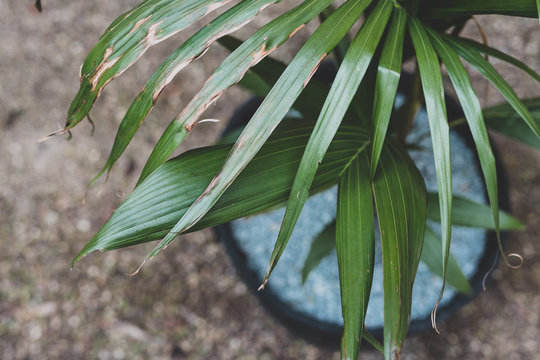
[231,106,487,328]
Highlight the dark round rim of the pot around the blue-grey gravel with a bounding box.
[214,64,510,349]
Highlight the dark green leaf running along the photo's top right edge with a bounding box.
[421,0,538,20]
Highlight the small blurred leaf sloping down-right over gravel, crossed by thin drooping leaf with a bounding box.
[421,226,472,295]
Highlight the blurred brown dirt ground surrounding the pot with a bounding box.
[0,0,540,360]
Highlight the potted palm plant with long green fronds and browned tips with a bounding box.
[63,0,540,359]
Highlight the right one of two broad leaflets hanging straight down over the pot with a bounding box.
[372,141,426,360]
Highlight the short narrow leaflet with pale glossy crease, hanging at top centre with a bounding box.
[371,8,407,174]
